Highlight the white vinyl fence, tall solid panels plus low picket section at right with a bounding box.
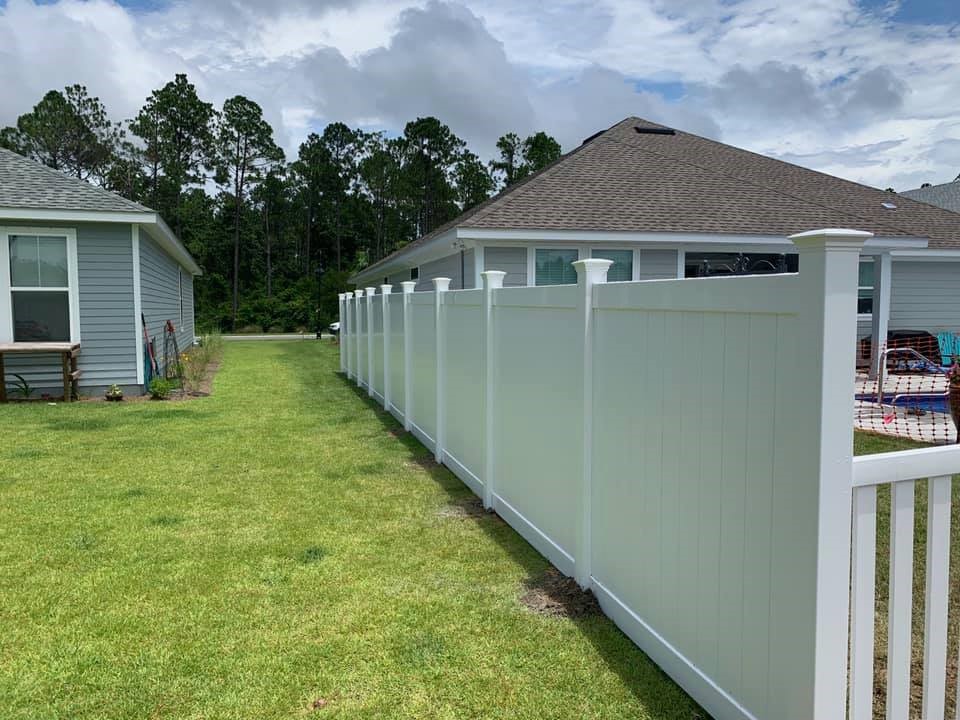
[340,230,960,720]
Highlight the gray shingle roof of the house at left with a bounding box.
[0,148,153,212]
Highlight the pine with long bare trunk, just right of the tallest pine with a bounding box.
[216,95,283,325]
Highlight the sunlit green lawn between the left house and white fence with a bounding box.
[0,342,701,720]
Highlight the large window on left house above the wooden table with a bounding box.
[6,234,71,342]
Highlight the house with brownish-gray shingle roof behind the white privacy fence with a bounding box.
[351,117,960,372]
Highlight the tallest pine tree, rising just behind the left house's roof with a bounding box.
[130,74,216,234]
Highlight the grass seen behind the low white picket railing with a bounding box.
[854,433,960,718]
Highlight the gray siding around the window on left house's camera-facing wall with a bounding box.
[5,221,137,396]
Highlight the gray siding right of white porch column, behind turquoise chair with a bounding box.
[890,260,960,335]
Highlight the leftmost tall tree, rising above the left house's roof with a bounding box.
[0,85,124,182]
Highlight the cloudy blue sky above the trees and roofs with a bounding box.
[0,0,960,190]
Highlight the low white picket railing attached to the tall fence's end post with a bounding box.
[850,446,960,720]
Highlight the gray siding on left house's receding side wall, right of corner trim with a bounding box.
[140,233,193,376]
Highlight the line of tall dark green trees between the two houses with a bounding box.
[0,74,561,331]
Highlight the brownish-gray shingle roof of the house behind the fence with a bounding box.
[358,117,960,276]
